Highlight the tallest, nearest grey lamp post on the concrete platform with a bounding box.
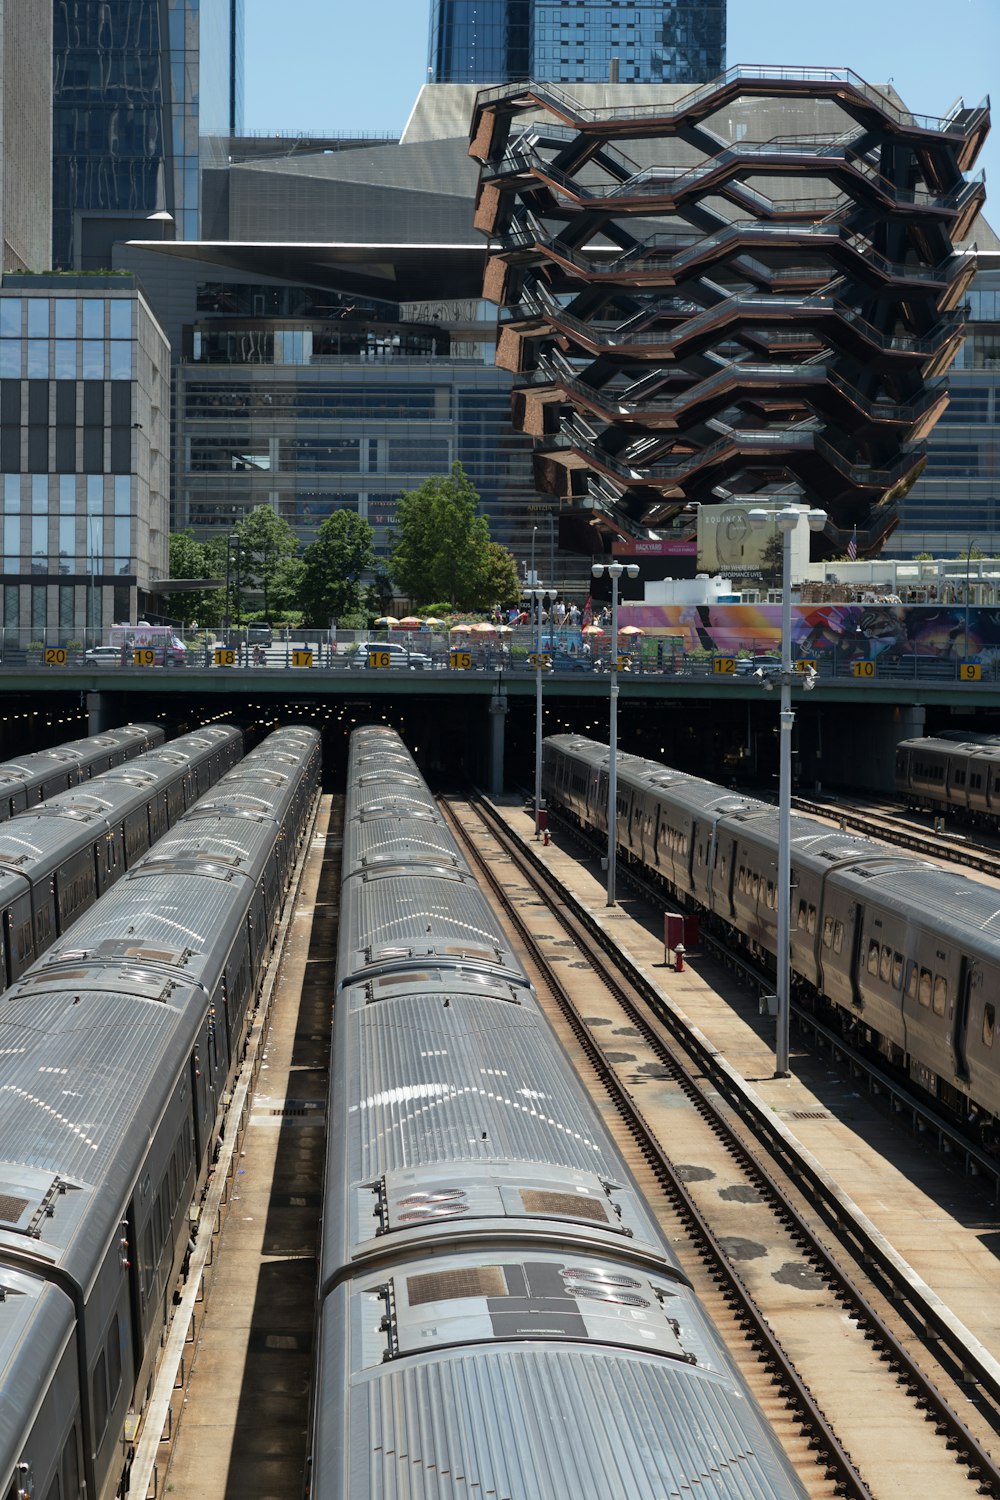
[750,506,826,1079]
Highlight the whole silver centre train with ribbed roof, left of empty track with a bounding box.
[309,726,804,1500]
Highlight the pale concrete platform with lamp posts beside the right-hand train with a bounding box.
[493,800,1000,1404]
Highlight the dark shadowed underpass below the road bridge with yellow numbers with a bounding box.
[0,657,1000,792]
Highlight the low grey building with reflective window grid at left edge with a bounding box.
[0,276,169,647]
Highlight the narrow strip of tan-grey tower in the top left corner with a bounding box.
[0,0,52,272]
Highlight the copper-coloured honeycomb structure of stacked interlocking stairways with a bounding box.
[469,68,990,554]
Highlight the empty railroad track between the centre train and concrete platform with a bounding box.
[440,803,1000,1500]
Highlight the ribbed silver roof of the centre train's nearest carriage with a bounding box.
[313,1256,802,1500]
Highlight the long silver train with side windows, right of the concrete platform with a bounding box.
[543,735,1000,1149]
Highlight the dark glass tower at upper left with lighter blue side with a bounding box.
[51,0,243,270]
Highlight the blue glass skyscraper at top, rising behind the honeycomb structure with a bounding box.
[429,0,726,84]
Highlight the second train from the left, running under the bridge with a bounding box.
[0,725,243,990]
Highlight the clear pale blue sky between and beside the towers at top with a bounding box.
[246,0,1000,198]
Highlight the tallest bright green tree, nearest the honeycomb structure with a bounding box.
[391,462,503,609]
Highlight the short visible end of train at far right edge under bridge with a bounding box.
[895,731,1000,828]
